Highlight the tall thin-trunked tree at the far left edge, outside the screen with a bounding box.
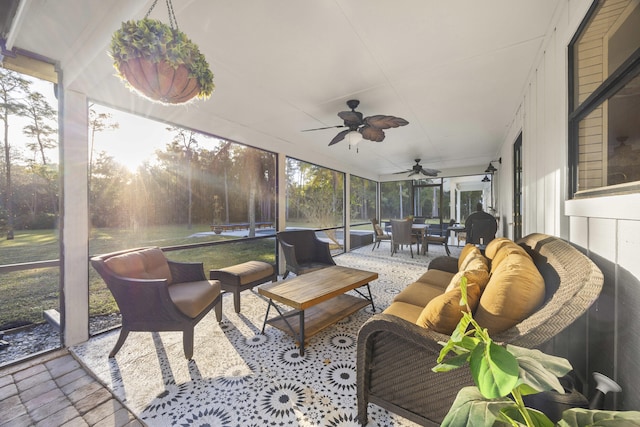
[0,68,31,240]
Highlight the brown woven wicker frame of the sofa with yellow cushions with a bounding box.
[357,234,603,426]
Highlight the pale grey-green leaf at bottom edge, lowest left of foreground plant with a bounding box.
[442,387,515,427]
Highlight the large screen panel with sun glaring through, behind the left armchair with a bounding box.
[88,104,276,333]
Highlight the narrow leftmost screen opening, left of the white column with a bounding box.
[0,65,61,365]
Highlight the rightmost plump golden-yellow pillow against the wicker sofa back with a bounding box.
[474,253,545,334]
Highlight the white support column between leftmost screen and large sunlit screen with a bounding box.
[60,90,90,347]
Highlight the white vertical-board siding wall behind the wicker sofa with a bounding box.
[498,0,640,410]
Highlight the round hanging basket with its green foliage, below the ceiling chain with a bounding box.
[109,18,214,104]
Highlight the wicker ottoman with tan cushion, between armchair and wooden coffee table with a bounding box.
[209,261,278,313]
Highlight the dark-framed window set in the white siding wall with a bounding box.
[569,0,640,197]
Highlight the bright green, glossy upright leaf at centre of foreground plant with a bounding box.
[469,341,519,399]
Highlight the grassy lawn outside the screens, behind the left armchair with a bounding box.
[0,225,275,330]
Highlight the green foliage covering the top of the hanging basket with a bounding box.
[109,18,214,99]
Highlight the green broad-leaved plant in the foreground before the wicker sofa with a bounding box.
[433,277,572,427]
